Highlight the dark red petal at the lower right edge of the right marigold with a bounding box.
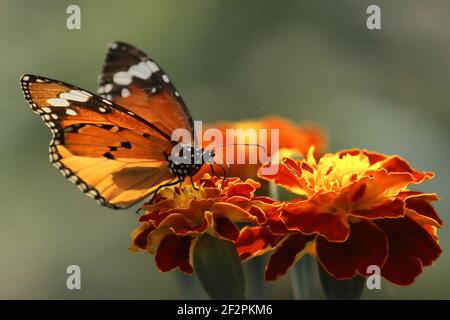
[376,217,441,285]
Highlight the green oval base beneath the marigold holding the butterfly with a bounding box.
[194,234,245,300]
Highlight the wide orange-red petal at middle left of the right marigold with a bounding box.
[281,200,349,241]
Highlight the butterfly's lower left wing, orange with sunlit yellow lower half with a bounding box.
[21,75,173,208]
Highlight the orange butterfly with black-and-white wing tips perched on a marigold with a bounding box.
[20,42,214,209]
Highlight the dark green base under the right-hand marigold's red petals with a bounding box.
[318,263,366,300]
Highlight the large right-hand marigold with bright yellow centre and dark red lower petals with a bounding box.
[236,149,442,285]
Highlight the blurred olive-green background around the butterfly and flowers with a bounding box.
[0,0,450,299]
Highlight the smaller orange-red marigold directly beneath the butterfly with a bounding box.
[130,175,274,274]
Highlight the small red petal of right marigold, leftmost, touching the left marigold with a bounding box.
[235,227,281,260]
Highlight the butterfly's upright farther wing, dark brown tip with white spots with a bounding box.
[99,42,194,142]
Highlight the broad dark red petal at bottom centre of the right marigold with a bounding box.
[316,220,388,279]
